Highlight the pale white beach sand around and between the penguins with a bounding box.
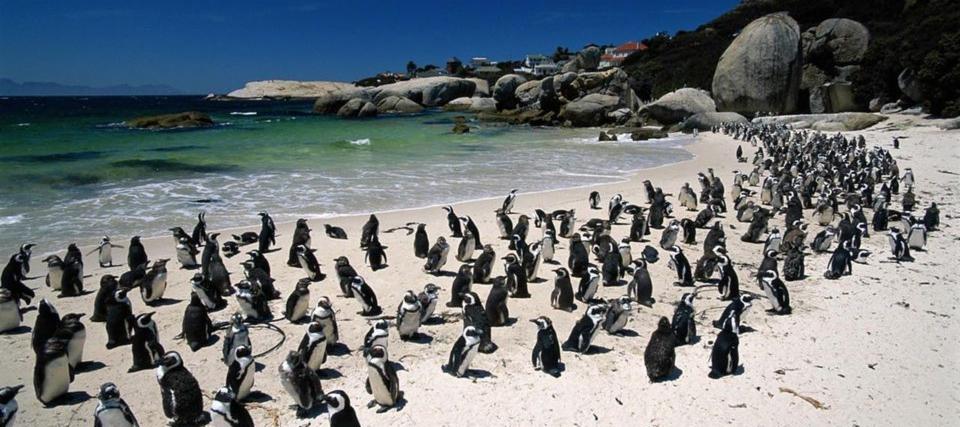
[0,116,960,426]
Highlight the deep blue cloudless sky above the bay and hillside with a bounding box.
[0,0,738,93]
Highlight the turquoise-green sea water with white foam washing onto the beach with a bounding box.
[0,97,690,253]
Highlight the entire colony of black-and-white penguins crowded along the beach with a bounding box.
[0,124,940,426]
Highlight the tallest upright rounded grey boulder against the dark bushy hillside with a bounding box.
[712,13,803,114]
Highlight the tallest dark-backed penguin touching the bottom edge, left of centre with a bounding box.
[156,351,206,425]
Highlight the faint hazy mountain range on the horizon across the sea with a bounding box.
[0,78,183,96]
